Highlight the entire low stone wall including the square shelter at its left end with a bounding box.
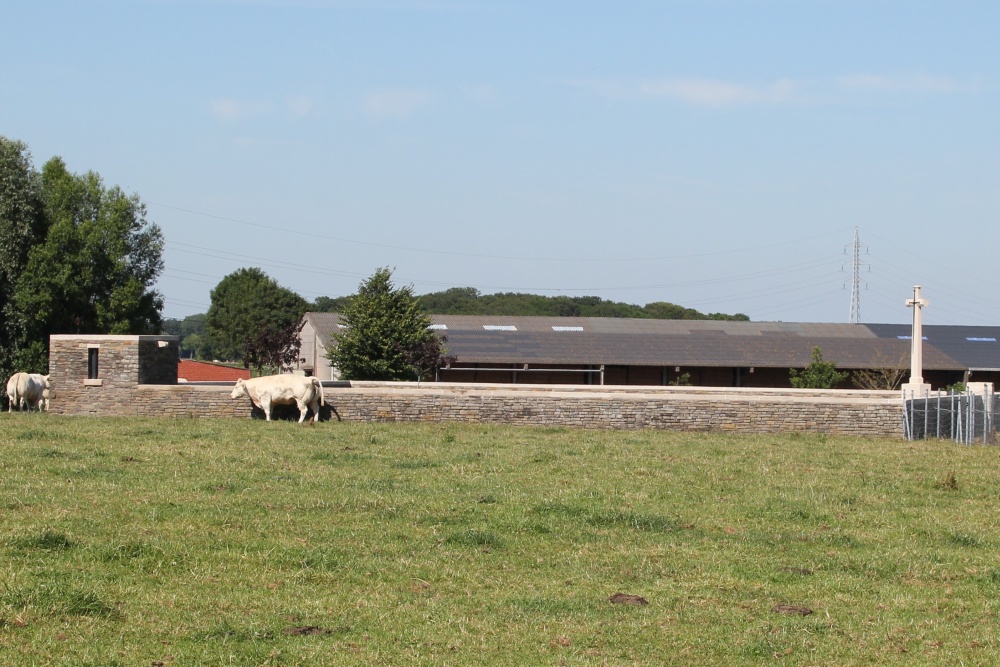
[49,335,902,437]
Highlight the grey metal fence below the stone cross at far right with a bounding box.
[903,389,1000,445]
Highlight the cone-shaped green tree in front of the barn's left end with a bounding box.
[327,268,448,380]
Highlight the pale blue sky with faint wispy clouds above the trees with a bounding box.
[0,0,1000,326]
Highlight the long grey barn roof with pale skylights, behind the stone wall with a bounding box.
[307,313,984,370]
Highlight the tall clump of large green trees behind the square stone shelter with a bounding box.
[0,136,163,377]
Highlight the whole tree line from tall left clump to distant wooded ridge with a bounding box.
[0,136,749,379]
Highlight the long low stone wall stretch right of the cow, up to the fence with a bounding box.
[327,382,902,437]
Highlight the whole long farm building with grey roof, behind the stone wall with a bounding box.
[298,313,1000,389]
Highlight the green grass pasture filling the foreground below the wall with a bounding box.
[0,414,1000,667]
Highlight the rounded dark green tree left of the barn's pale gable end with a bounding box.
[205,268,309,367]
